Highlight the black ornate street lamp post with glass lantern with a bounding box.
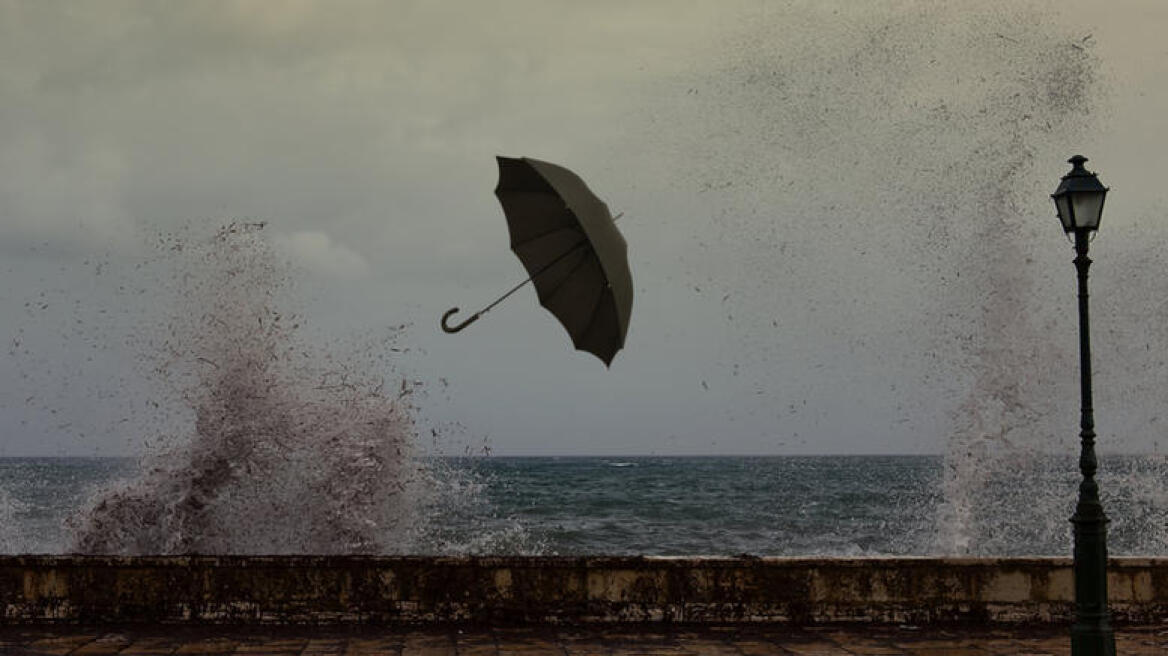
[1051,155,1115,656]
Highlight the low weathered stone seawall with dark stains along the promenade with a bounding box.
[0,556,1168,624]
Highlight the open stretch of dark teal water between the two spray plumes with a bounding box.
[446,456,940,554]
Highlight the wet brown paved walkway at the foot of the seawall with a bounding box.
[0,626,1168,656]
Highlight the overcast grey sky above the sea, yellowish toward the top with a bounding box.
[0,0,1168,455]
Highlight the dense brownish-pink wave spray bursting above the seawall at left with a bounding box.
[70,223,434,553]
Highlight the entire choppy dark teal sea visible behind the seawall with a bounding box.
[0,455,1164,557]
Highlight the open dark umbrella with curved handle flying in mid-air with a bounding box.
[442,156,633,365]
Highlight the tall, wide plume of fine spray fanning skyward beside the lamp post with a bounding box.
[640,1,1150,554]
